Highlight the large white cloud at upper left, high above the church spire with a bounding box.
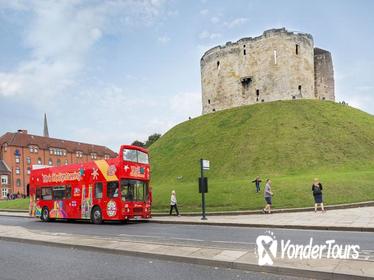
[0,0,169,104]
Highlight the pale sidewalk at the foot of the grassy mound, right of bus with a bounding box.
[151,207,374,232]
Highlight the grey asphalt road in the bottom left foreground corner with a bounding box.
[0,241,302,280]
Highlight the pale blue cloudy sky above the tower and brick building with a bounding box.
[0,0,374,151]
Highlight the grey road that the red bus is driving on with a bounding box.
[0,216,374,254]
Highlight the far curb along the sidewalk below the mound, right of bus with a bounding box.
[144,220,374,232]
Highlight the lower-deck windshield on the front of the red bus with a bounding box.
[121,179,148,201]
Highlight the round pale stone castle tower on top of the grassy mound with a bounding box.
[200,28,335,114]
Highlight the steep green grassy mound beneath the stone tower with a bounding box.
[150,100,374,211]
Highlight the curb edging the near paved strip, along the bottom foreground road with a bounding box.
[0,236,369,280]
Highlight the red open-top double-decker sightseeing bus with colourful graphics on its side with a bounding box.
[29,145,152,224]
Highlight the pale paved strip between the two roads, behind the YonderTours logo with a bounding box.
[0,222,374,279]
